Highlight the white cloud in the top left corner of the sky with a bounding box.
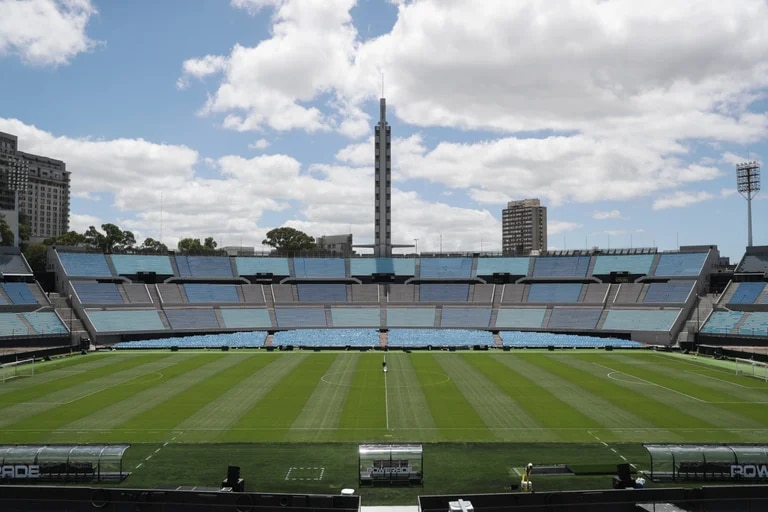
[0,0,97,66]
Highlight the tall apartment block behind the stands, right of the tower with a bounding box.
[501,199,547,255]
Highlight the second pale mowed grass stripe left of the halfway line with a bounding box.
[175,353,309,442]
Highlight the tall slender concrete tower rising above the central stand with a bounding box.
[373,98,392,258]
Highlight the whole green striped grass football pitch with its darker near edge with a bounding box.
[0,350,768,504]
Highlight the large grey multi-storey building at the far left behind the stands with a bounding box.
[0,132,70,242]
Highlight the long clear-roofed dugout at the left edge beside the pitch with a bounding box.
[0,444,130,483]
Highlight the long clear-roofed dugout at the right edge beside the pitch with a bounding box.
[643,444,768,482]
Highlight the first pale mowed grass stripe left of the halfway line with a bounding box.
[286,353,359,441]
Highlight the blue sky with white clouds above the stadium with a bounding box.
[0,0,768,263]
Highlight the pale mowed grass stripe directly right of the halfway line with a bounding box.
[385,352,439,441]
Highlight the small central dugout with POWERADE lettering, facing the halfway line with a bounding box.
[358,444,424,485]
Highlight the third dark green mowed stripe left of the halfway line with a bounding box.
[118,353,282,441]
